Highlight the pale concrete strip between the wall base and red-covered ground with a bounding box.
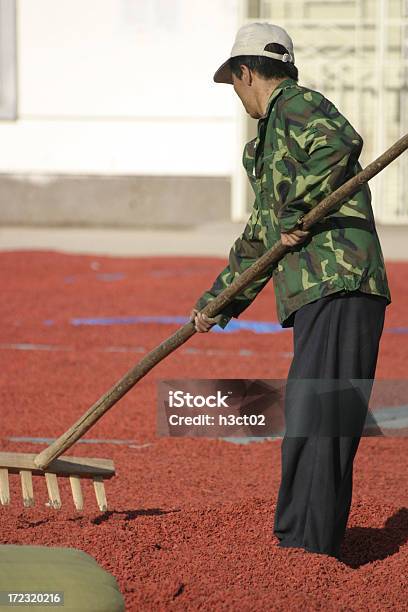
[0,221,408,261]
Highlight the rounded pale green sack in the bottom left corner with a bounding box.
[0,545,125,612]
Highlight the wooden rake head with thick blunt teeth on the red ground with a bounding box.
[0,453,115,512]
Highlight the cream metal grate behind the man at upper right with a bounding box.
[233,0,408,223]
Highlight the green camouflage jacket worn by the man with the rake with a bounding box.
[195,78,391,327]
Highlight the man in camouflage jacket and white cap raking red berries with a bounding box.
[190,23,391,557]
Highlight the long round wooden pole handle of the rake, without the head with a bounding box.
[34,134,408,470]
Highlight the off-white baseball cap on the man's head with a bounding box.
[214,22,295,85]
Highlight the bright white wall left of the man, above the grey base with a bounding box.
[0,0,240,176]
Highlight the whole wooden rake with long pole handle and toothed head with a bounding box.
[0,134,408,511]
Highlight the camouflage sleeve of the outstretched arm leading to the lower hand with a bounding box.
[195,213,273,328]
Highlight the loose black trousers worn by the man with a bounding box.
[274,291,386,558]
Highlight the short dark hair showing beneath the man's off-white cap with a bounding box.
[229,43,298,81]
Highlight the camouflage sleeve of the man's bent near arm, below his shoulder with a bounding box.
[274,98,363,232]
